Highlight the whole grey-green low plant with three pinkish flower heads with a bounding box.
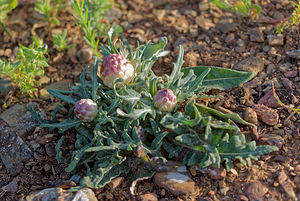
[33,30,278,188]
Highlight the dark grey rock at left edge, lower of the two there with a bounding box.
[0,120,32,175]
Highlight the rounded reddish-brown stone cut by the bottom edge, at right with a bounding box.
[246,181,269,200]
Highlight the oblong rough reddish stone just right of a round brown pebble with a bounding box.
[252,104,279,126]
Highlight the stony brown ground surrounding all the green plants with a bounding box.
[0,0,300,201]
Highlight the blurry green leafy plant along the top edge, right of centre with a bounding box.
[208,0,261,19]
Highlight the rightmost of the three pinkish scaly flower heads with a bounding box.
[153,88,177,112]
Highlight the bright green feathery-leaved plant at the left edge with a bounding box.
[0,37,48,95]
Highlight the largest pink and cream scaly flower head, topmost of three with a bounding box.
[100,54,135,88]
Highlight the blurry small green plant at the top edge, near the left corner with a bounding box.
[35,0,66,27]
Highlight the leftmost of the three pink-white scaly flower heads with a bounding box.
[74,99,98,122]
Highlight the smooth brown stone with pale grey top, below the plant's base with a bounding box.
[154,171,195,196]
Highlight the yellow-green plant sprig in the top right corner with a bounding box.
[276,0,300,34]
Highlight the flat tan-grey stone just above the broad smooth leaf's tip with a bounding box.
[234,57,264,75]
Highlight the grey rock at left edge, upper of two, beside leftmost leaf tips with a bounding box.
[0,103,45,137]
